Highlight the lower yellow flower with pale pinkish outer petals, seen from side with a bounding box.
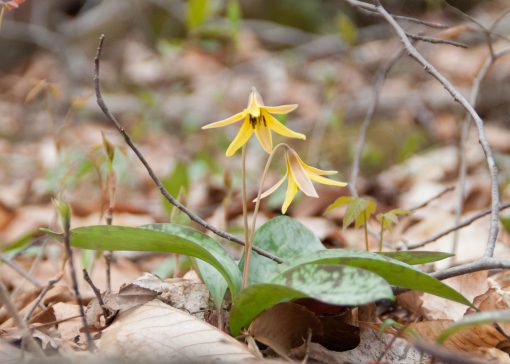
[260,148,347,214]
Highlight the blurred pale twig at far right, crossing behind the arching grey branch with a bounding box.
[452,47,510,254]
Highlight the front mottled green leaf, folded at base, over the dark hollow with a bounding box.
[229,264,393,336]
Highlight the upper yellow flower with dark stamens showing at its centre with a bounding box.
[202,87,306,157]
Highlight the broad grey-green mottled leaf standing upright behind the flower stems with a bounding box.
[245,216,325,283]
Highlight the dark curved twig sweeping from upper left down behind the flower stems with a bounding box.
[94,34,283,263]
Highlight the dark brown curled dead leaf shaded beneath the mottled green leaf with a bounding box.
[248,302,322,358]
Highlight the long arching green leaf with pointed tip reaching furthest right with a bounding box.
[280,249,472,306]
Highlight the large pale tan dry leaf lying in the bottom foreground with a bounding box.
[99,300,255,363]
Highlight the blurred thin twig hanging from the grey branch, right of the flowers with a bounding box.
[349,48,404,197]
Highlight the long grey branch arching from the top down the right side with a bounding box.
[362,0,499,257]
